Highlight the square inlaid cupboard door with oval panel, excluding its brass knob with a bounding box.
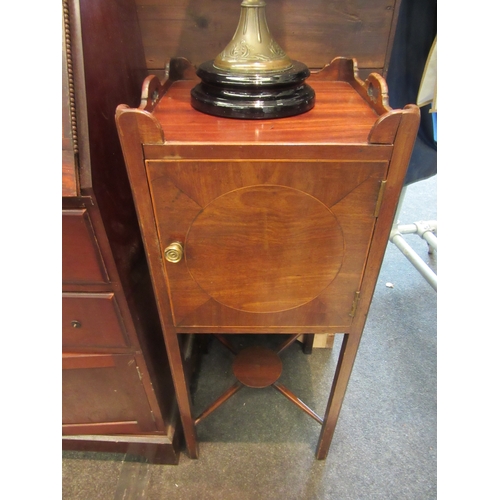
[147,161,387,329]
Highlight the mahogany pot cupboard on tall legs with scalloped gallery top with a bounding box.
[116,58,420,459]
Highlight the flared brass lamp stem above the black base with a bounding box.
[214,0,292,73]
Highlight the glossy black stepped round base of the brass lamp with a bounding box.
[191,61,315,120]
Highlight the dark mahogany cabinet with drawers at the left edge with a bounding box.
[62,0,181,464]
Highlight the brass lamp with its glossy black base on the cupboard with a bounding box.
[191,0,315,119]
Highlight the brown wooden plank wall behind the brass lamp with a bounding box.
[136,0,399,73]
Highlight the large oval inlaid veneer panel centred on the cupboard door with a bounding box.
[185,185,344,313]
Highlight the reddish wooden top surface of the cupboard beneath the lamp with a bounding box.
[153,80,379,144]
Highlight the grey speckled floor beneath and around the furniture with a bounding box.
[62,176,437,500]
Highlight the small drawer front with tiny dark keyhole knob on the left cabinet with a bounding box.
[62,293,129,348]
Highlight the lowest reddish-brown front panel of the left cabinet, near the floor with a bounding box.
[62,354,157,435]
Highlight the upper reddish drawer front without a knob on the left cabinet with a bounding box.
[62,209,109,283]
